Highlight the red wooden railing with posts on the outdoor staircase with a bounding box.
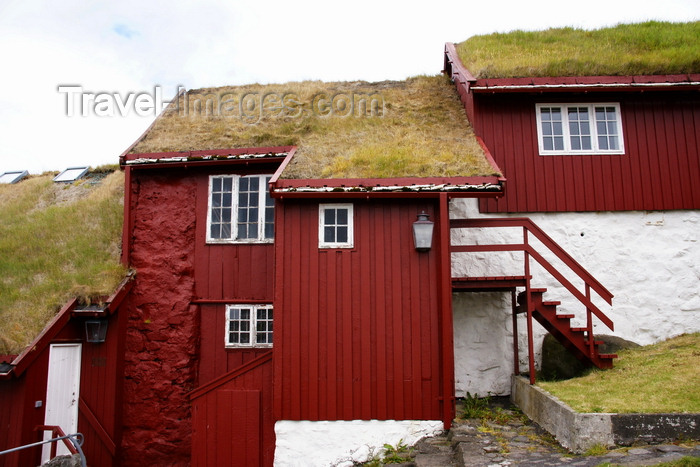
[450,217,614,384]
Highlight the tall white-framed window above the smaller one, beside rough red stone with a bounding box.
[207,175,275,243]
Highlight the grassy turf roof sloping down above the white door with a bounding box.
[0,172,125,354]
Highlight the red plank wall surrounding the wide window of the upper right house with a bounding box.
[472,91,700,212]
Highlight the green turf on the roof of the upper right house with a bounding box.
[456,21,700,79]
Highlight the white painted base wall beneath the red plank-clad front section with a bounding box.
[275,420,443,467]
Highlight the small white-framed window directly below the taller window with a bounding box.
[226,305,273,348]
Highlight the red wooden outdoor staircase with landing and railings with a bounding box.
[450,218,617,384]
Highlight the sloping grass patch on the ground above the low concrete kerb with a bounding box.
[538,333,700,413]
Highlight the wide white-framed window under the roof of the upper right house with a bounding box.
[536,103,625,155]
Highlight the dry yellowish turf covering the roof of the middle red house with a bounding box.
[132,75,497,178]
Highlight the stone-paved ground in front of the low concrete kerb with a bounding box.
[388,401,700,467]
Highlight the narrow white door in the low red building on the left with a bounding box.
[41,344,82,463]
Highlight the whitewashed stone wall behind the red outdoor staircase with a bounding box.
[451,199,700,396]
